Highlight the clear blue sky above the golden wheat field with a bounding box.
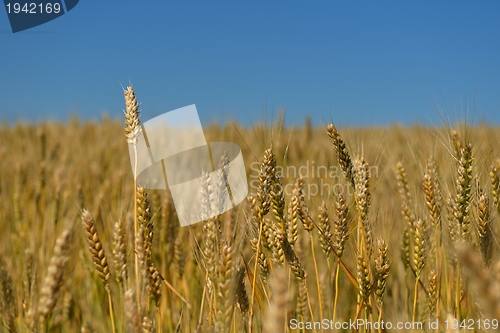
[0,0,500,125]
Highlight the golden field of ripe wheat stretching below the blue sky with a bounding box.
[0,87,500,333]
